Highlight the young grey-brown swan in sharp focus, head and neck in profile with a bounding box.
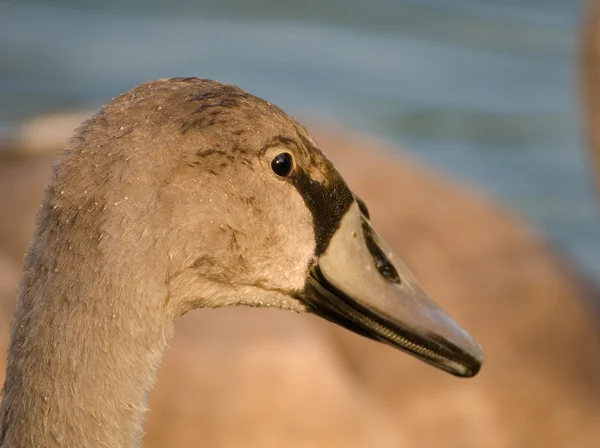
[0,78,483,448]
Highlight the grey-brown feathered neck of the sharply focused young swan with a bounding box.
[0,198,173,448]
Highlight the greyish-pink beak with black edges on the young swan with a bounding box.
[305,201,483,377]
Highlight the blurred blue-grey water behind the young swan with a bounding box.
[0,0,600,281]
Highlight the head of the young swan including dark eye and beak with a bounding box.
[51,78,483,377]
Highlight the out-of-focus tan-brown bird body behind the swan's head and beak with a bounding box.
[0,108,600,448]
